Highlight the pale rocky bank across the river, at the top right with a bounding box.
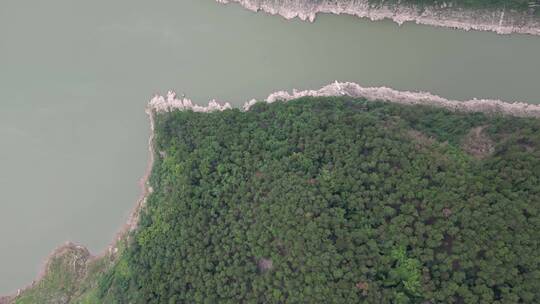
[216,0,540,35]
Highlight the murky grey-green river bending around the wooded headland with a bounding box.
[0,0,540,294]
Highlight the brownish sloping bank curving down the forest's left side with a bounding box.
[5,107,155,304]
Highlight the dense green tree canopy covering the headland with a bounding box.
[98,98,540,303]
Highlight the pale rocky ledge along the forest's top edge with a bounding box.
[149,81,540,117]
